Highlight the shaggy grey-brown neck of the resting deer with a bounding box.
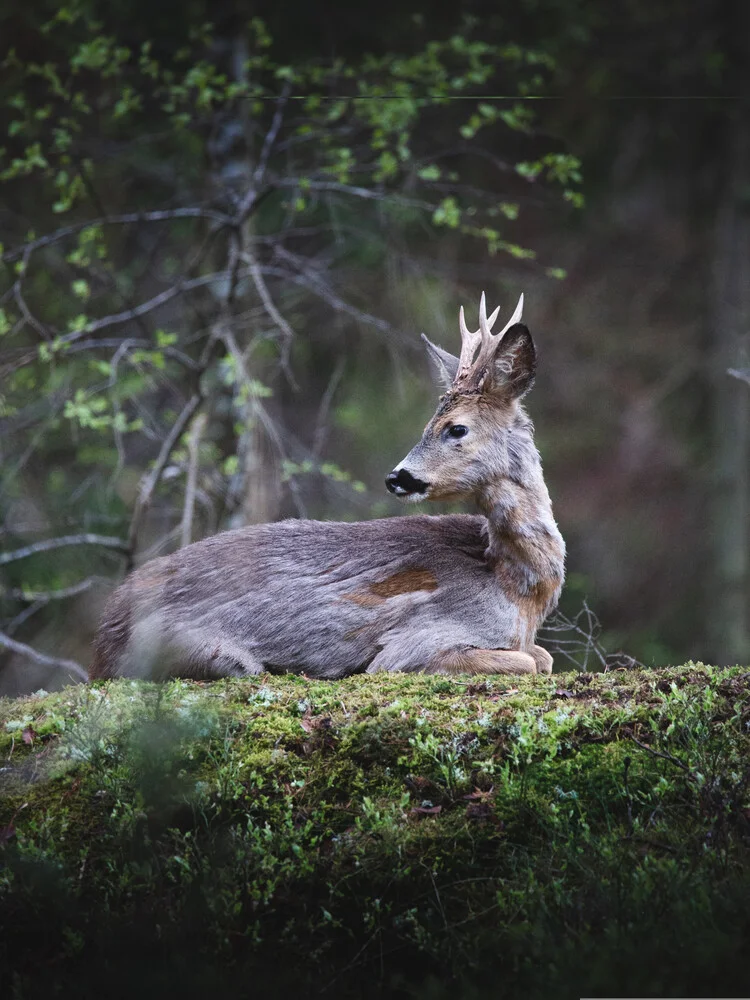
[477,442,565,616]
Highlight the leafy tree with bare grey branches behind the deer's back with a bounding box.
[0,0,580,680]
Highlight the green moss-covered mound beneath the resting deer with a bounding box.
[0,664,750,1000]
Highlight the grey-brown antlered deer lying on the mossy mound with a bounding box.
[90,295,565,678]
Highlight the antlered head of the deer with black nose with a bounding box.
[385,292,538,501]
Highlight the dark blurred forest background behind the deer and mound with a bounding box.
[0,0,750,694]
